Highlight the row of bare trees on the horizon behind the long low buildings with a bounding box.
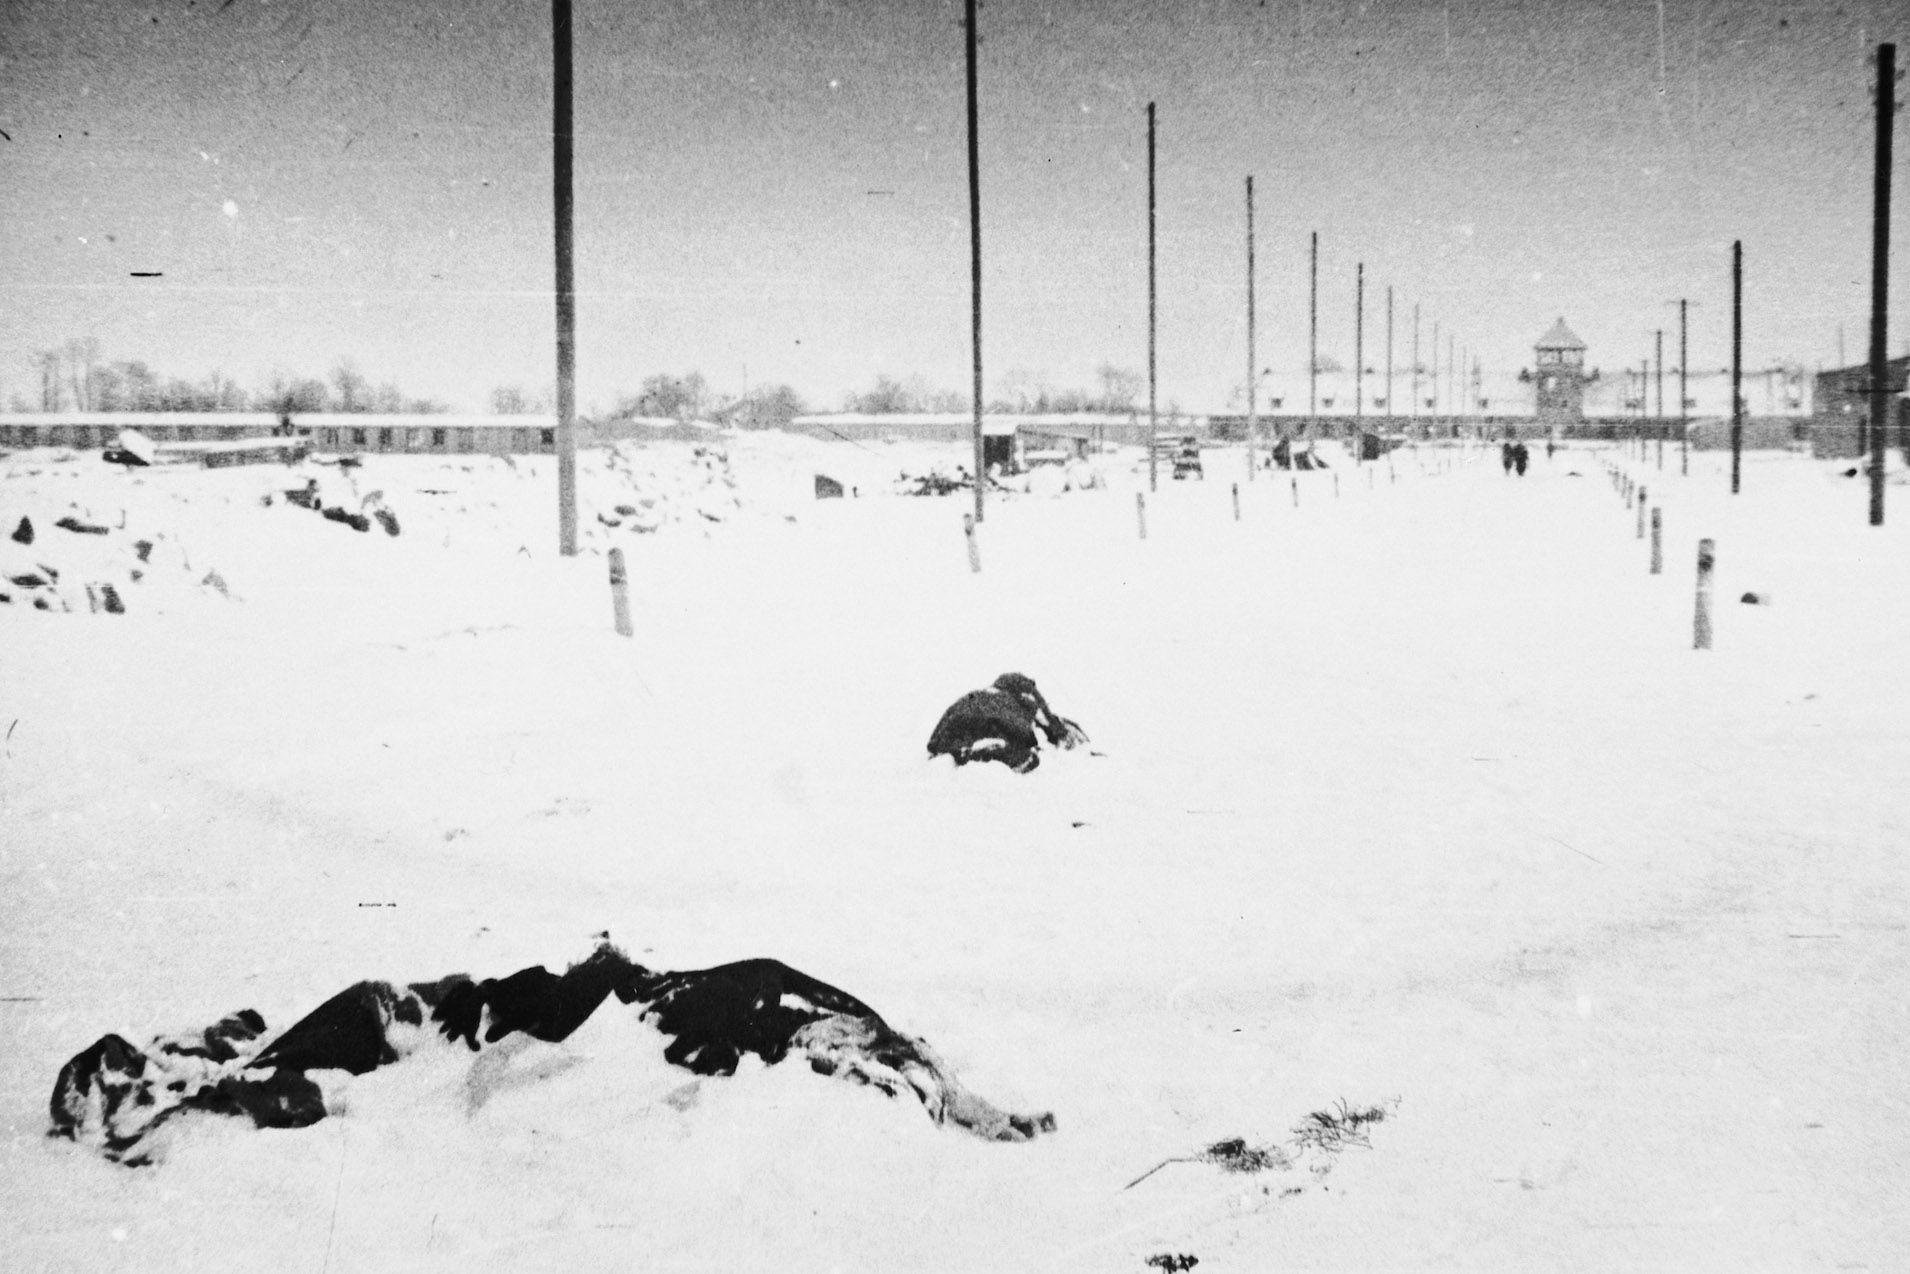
[8,338,1146,430]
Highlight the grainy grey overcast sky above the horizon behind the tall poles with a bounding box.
[0,0,1910,411]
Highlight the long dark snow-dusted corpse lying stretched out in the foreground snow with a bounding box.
[52,940,1054,1165]
